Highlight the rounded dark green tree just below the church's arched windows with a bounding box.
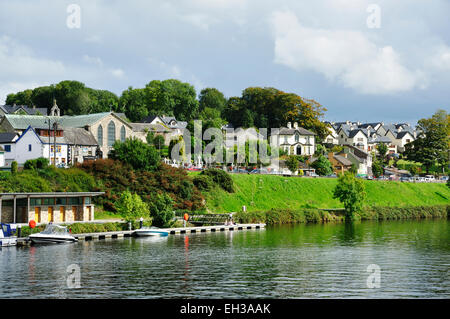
[108,137,160,171]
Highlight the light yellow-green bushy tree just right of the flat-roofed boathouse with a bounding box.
[115,190,150,222]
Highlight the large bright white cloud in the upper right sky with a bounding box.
[271,11,426,94]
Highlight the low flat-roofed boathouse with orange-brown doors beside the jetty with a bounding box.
[0,192,104,223]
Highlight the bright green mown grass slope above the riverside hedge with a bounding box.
[206,174,450,213]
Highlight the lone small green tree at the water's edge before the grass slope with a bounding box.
[333,172,366,220]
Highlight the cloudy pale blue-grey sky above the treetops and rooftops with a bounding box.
[0,0,450,124]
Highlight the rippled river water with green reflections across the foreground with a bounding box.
[0,220,450,298]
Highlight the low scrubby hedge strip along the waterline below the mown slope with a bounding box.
[234,205,450,225]
